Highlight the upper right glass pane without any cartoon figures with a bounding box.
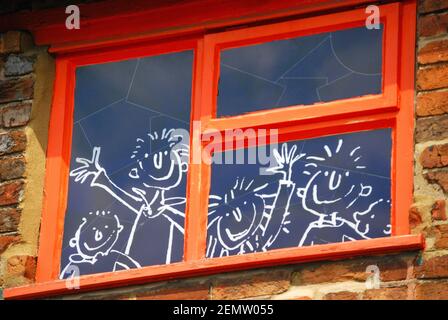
[217,27,383,117]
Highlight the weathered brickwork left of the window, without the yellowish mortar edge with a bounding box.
[0,31,36,286]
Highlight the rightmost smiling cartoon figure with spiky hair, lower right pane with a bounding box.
[297,139,390,246]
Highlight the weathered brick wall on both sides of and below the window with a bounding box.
[0,0,448,300]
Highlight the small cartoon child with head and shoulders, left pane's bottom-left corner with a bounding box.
[60,211,140,279]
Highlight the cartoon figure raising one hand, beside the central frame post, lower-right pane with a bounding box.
[206,144,304,257]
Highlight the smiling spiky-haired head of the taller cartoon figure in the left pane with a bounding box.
[129,130,188,190]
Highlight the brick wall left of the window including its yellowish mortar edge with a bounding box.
[0,31,54,297]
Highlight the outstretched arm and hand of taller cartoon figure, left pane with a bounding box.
[70,147,144,214]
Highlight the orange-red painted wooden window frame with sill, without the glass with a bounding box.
[4,0,424,299]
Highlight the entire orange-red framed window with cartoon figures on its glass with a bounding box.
[8,3,423,296]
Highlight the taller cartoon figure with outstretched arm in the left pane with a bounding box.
[70,129,189,263]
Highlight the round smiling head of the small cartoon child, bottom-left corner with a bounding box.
[70,211,123,258]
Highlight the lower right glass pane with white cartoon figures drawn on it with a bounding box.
[207,129,391,257]
